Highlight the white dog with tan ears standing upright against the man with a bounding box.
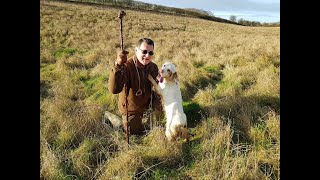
[148,62,189,141]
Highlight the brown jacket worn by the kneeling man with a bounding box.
[108,56,160,114]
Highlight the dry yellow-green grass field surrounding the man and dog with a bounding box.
[40,0,280,180]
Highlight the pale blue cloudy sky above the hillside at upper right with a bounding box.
[139,0,280,23]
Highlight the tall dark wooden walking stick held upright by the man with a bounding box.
[118,10,130,144]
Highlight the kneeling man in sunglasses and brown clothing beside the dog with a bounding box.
[108,38,161,134]
